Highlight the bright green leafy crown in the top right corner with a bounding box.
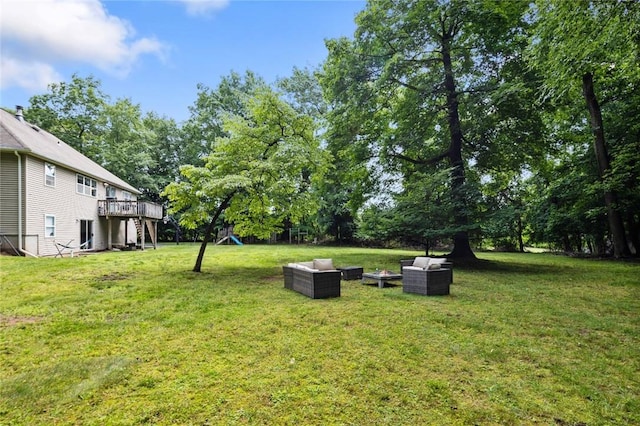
[530,0,640,99]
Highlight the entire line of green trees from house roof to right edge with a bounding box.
[16,0,640,270]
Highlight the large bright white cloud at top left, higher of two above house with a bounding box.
[0,0,166,88]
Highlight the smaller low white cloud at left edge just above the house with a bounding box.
[0,55,63,92]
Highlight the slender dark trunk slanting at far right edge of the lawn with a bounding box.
[582,73,631,257]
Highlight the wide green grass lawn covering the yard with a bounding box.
[0,244,640,425]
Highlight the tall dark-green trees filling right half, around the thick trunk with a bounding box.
[321,0,640,257]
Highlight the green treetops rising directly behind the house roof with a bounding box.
[25,74,185,201]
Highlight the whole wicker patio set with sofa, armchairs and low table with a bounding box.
[282,257,453,299]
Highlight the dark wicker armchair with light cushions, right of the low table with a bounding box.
[401,257,453,296]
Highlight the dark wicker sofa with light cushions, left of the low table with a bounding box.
[282,259,342,299]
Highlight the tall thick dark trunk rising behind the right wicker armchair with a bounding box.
[442,29,476,258]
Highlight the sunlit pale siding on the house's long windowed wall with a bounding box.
[24,157,136,256]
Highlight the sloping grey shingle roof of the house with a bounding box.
[0,109,140,194]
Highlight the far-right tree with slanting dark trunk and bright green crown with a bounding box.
[531,0,640,257]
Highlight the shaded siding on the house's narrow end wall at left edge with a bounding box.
[0,152,19,247]
